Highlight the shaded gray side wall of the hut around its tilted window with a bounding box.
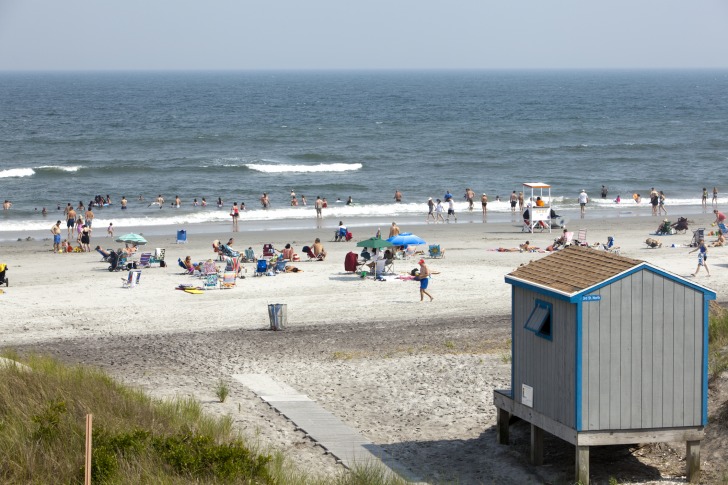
[513,287,576,427]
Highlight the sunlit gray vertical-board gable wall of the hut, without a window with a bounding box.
[581,270,703,431]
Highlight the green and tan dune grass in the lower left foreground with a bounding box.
[0,352,406,485]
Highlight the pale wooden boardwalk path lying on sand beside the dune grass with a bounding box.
[233,374,421,482]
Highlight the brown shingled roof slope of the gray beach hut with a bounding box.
[506,246,644,295]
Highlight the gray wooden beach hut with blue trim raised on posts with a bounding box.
[493,247,716,484]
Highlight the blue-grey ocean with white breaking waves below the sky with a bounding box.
[0,71,728,232]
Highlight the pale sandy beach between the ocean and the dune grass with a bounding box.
[0,212,728,483]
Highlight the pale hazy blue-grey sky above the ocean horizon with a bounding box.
[0,0,728,70]
